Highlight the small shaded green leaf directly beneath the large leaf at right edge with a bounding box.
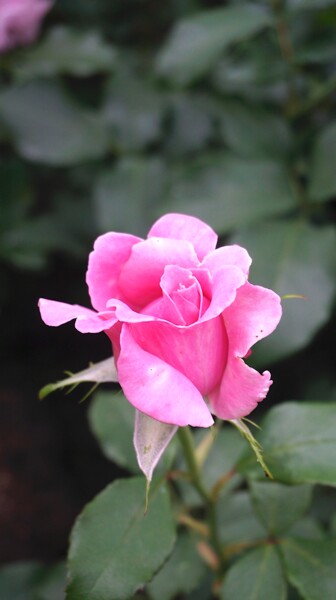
[250,481,312,536]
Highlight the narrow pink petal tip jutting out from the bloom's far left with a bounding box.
[39,298,117,333]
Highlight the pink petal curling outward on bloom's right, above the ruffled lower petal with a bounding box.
[223,283,282,357]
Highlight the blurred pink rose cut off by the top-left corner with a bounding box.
[0,0,52,52]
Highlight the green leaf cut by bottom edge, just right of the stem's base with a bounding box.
[220,544,287,600]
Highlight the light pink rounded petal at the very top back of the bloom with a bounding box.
[148,213,217,260]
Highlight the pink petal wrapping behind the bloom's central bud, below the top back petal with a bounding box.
[119,237,198,308]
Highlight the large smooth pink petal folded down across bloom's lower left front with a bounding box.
[117,325,213,427]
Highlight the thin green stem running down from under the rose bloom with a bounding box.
[178,427,224,571]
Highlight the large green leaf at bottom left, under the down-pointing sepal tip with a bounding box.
[66,477,175,600]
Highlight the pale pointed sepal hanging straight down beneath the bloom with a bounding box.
[134,410,177,482]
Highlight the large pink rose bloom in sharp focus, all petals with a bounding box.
[39,214,281,427]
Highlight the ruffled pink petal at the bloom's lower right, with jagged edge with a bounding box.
[208,354,272,420]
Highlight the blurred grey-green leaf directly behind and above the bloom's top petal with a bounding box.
[166,153,296,233]
